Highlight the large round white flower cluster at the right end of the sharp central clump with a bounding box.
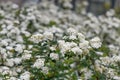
[90,37,102,48]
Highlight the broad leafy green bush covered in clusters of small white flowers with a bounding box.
[0,0,120,80]
